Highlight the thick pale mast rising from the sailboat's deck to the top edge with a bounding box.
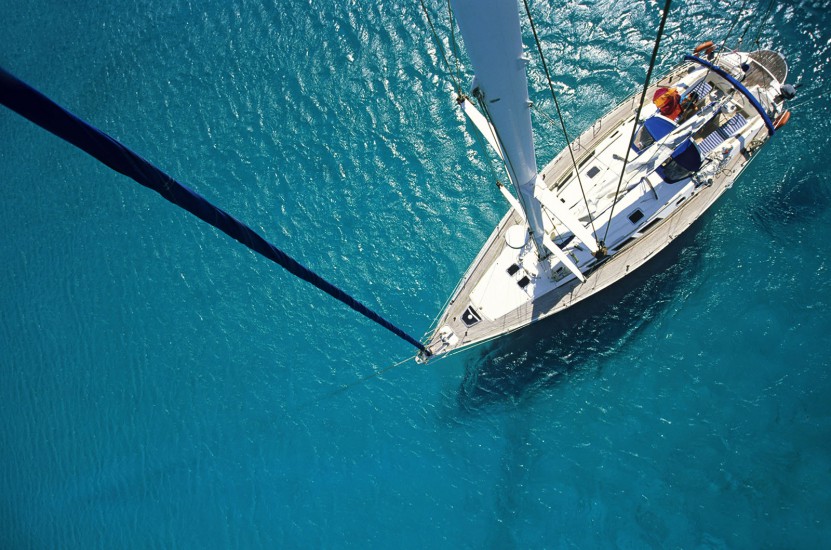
[451,0,549,258]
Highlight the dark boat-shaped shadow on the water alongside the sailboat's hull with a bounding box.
[457,229,703,412]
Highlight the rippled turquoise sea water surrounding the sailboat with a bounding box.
[0,0,831,548]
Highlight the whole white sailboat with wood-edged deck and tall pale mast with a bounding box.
[418,0,795,362]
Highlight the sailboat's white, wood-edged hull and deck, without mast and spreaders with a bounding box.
[421,50,784,359]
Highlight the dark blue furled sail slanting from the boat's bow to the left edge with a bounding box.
[0,68,430,355]
